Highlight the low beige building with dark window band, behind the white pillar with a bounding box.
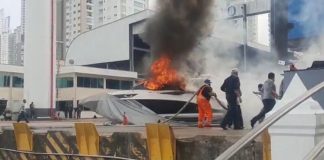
[0,65,137,117]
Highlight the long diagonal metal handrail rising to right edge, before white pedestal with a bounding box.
[215,82,324,160]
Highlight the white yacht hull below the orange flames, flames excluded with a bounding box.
[112,84,225,123]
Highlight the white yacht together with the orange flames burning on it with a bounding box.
[112,56,225,121]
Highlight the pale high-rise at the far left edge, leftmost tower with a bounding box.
[0,9,10,64]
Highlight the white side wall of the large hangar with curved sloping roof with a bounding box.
[66,10,152,65]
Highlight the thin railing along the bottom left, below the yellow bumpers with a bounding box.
[0,148,135,160]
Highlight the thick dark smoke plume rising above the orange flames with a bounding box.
[144,0,213,63]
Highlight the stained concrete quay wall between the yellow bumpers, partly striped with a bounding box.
[0,128,263,160]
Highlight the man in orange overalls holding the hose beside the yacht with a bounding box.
[197,79,216,128]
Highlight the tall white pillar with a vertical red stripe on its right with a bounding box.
[24,0,55,108]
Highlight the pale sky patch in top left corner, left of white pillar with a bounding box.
[0,0,21,30]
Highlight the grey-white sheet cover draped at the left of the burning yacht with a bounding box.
[80,94,172,125]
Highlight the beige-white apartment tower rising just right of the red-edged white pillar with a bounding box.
[65,0,96,47]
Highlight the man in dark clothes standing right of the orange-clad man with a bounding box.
[221,69,244,130]
